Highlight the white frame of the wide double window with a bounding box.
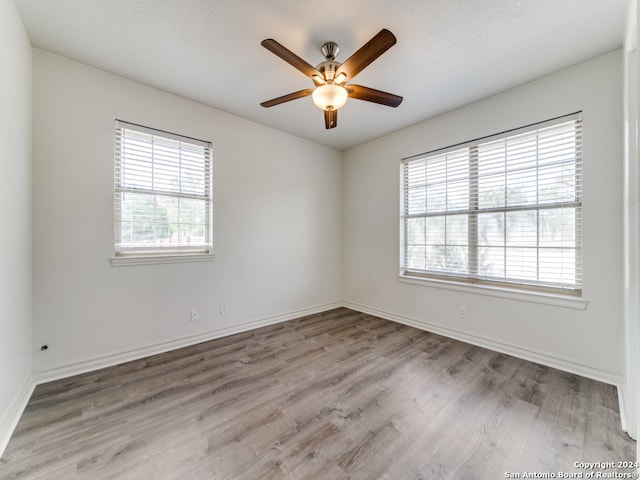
[399,112,586,298]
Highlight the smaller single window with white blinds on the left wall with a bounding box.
[115,121,212,257]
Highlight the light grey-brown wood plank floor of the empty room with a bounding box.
[0,308,636,480]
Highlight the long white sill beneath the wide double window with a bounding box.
[398,275,589,310]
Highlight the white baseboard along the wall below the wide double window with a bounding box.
[342,302,622,386]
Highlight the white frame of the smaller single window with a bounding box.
[110,119,214,266]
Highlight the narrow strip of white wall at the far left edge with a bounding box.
[0,0,32,454]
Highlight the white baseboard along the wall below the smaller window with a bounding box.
[33,302,342,385]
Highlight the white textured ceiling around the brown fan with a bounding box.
[15,0,626,150]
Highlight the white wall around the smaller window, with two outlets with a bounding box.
[33,49,342,380]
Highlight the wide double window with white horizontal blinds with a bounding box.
[401,114,582,296]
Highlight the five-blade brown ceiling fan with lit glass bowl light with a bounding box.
[260,29,402,129]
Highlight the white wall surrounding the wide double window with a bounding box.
[343,51,624,383]
